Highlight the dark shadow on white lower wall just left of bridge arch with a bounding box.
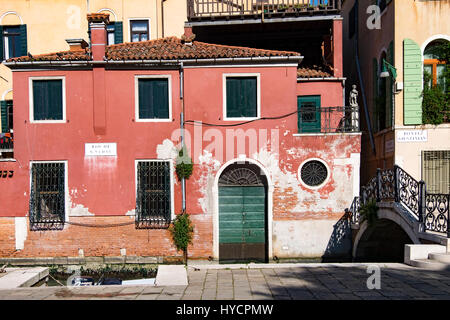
[322,214,352,262]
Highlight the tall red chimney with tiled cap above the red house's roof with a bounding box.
[87,13,109,61]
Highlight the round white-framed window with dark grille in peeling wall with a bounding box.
[298,158,330,189]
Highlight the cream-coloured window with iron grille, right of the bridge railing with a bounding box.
[422,150,450,193]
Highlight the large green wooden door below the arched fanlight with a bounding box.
[219,186,266,261]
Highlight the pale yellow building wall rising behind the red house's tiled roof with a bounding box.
[0,0,187,99]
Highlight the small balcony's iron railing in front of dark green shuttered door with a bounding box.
[298,105,359,133]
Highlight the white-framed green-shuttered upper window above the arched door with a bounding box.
[223,73,261,121]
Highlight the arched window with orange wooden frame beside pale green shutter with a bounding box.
[423,39,449,91]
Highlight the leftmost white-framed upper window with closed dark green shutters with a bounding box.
[29,76,66,123]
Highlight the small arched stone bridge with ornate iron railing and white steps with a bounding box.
[347,166,450,269]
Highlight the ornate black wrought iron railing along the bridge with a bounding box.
[346,166,450,237]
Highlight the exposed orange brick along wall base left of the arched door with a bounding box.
[0,215,212,258]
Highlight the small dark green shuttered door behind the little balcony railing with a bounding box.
[297,96,321,133]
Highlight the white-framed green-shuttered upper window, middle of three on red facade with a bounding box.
[135,75,172,122]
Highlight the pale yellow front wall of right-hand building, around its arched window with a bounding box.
[395,0,450,180]
